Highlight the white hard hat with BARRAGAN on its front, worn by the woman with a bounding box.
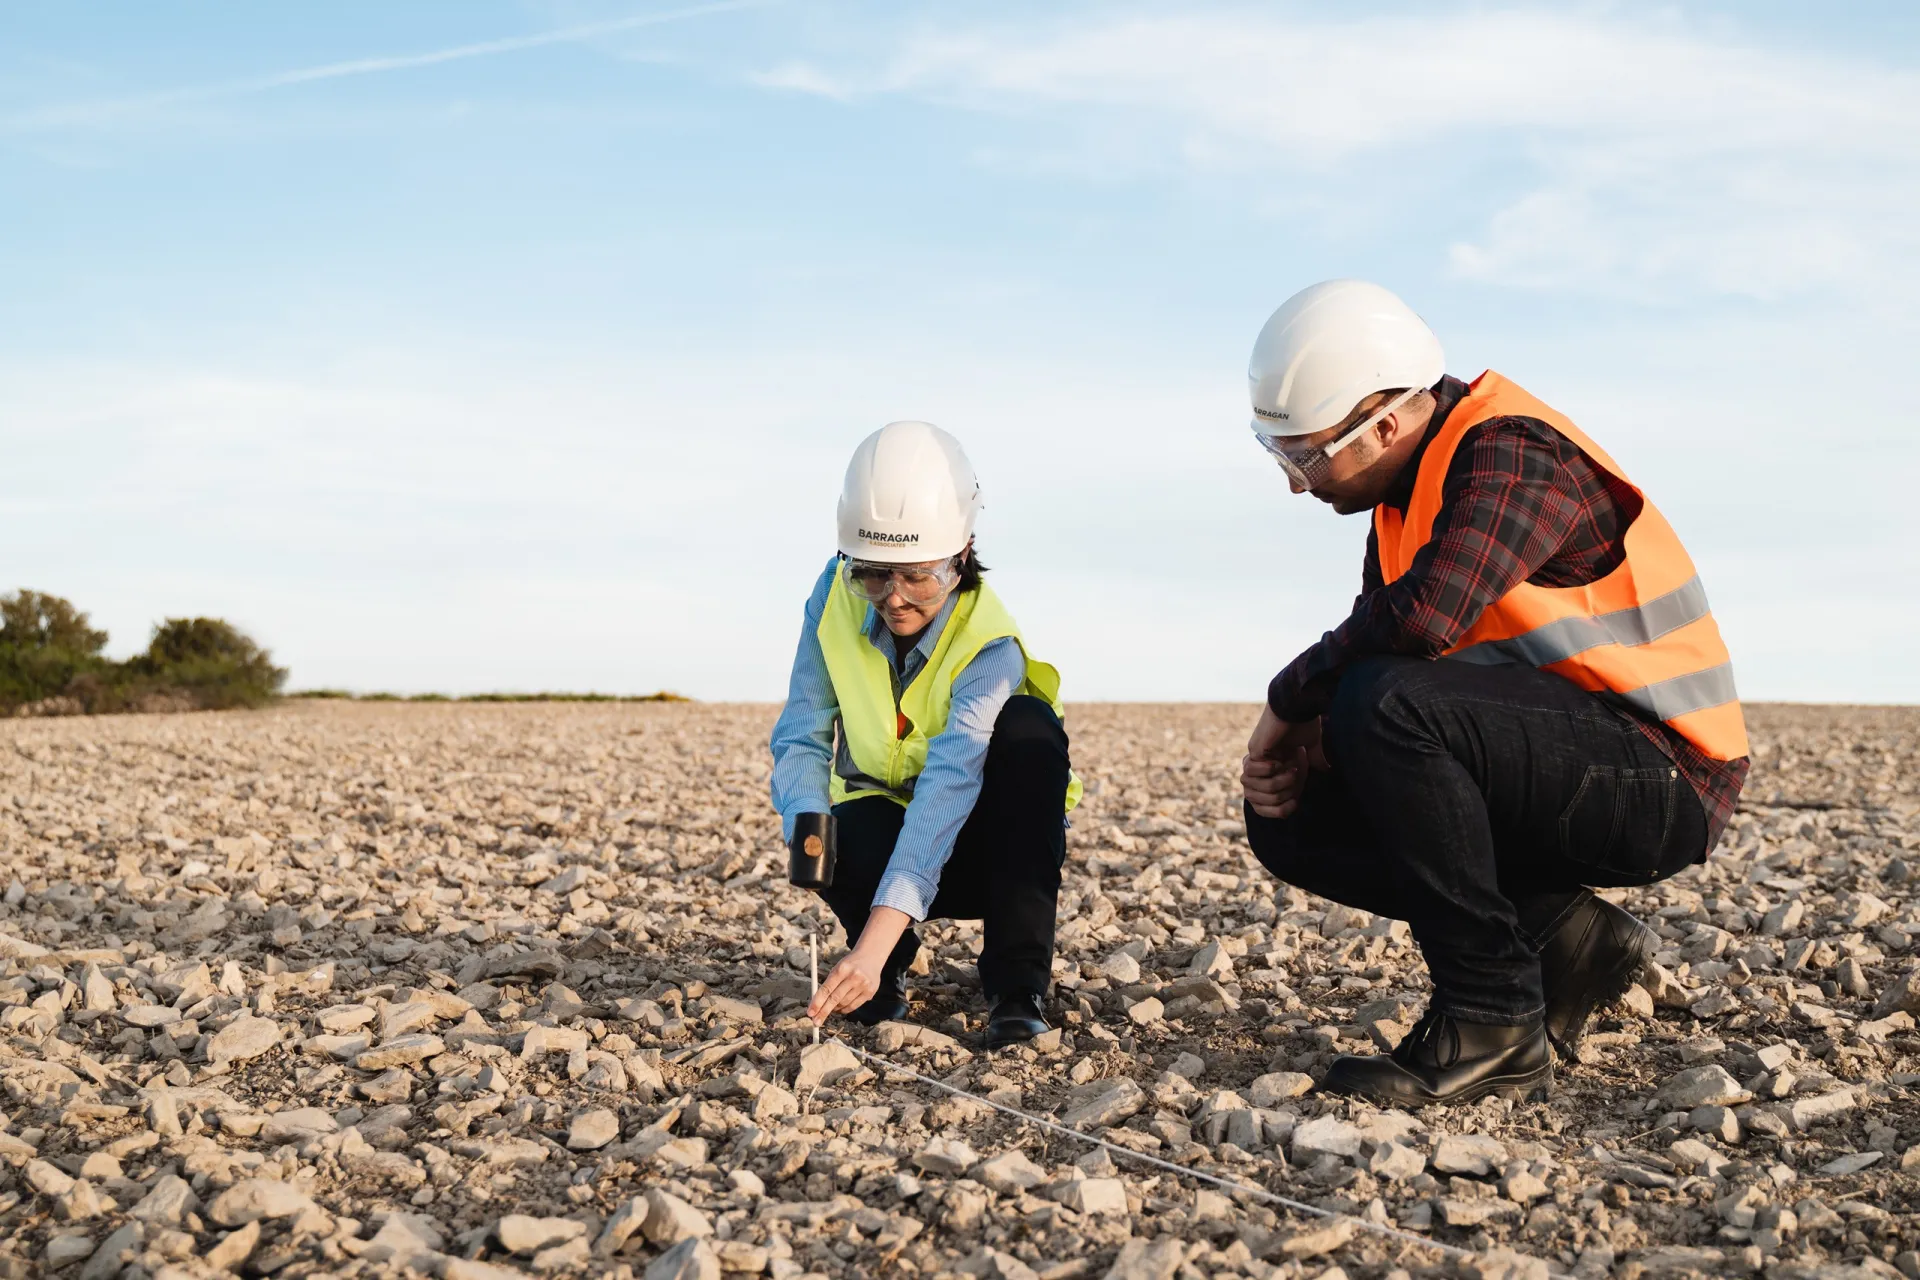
[839,422,979,564]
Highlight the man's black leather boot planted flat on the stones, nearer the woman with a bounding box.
[1321,1009,1553,1107]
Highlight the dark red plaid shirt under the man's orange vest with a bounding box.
[1267,378,1747,848]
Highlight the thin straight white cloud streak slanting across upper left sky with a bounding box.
[0,0,780,132]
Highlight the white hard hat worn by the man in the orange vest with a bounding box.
[1246,280,1446,436]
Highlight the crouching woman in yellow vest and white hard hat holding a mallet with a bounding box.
[772,422,1079,1048]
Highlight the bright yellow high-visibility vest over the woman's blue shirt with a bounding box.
[814,574,1081,810]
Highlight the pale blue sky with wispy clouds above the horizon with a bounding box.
[0,0,1920,700]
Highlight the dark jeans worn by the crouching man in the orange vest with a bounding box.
[1246,658,1707,1025]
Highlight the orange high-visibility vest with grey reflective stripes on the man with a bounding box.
[1373,370,1747,760]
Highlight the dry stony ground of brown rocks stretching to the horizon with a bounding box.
[0,702,1920,1280]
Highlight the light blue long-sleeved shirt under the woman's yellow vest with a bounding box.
[770,557,1027,919]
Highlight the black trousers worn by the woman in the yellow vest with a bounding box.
[820,695,1068,1000]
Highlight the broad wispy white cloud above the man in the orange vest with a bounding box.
[756,8,1920,301]
